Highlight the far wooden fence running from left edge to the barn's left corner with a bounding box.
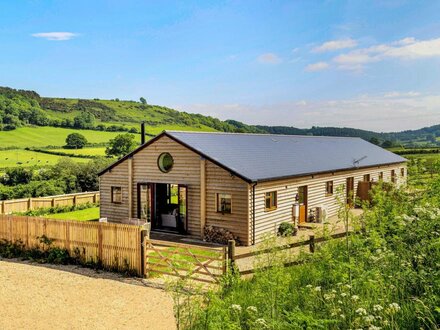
[0,191,100,214]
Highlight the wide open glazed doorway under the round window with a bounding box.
[138,183,188,233]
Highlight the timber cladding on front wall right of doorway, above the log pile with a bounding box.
[206,161,250,245]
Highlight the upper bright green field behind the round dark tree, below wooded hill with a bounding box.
[0,127,136,148]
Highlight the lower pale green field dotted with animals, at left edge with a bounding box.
[0,149,89,168]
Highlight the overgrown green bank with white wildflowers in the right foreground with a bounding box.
[175,179,440,329]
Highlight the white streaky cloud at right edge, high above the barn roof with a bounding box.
[332,37,440,70]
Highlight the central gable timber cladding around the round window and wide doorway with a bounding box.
[131,136,201,236]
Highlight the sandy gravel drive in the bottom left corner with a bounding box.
[0,260,176,330]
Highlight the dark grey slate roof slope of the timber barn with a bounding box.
[166,131,406,182]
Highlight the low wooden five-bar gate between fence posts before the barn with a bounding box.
[144,239,227,283]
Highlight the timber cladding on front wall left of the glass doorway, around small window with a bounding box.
[99,162,129,222]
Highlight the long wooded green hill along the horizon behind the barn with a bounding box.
[0,87,440,147]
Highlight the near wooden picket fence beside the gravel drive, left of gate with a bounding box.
[0,215,143,275]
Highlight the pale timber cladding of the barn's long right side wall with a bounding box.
[249,163,407,243]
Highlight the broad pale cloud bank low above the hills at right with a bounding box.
[177,91,440,132]
